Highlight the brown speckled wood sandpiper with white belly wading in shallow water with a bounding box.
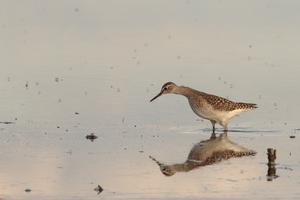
[150,82,257,133]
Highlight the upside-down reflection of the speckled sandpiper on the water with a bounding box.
[149,132,256,176]
